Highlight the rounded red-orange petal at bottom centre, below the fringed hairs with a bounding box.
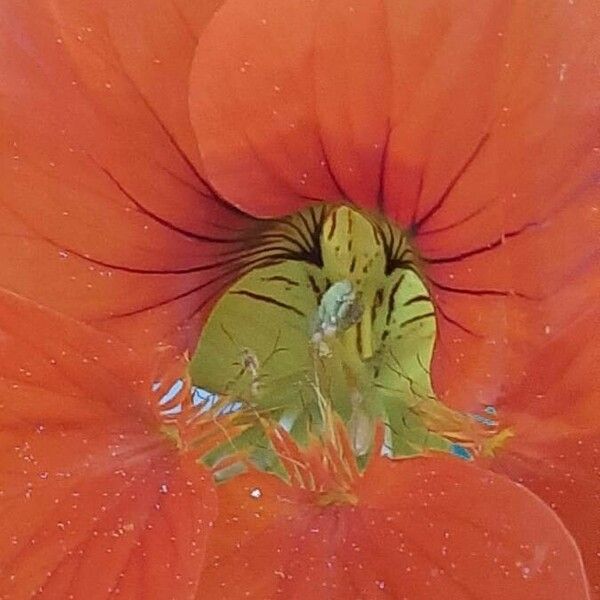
[203,458,588,600]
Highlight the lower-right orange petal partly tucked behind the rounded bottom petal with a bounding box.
[490,307,600,597]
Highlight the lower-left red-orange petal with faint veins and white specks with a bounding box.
[0,292,216,599]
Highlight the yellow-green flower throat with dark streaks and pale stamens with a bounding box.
[190,205,494,468]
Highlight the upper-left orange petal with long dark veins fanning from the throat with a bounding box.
[0,0,258,354]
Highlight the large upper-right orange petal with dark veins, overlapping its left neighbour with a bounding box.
[191,0,600,408]
